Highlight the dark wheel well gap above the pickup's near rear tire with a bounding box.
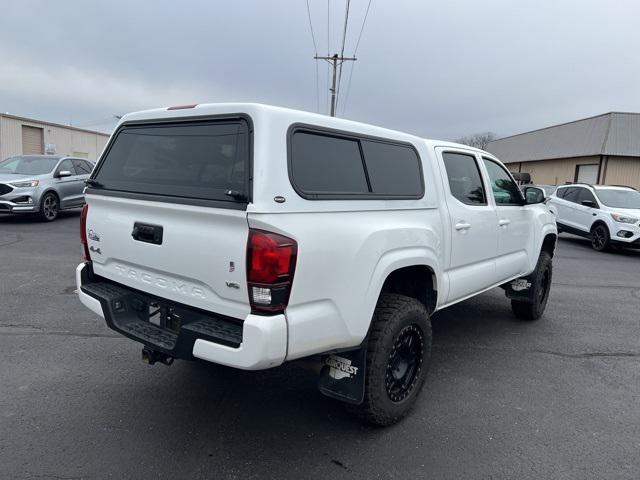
[380,265,438,313]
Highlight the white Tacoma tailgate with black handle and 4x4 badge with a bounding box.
[86,194,251,318]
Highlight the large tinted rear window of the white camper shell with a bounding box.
[94,119,250,202]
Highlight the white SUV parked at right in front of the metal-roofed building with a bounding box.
[547,184,640,251]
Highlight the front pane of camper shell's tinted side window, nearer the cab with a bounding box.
[362,140,423,195]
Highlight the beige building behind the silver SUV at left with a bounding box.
[0,113,109,162]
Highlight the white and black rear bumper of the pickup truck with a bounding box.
[76,263,287,370]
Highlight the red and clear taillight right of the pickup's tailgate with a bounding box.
[247,229,298,313]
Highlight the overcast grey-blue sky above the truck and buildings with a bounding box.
[0,0,640,139]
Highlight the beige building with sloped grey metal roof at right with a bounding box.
[487,112,640,189]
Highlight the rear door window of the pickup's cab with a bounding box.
[442,152,487,205]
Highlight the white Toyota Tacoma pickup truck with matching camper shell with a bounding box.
[76,104,557,425]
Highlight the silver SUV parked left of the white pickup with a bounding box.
[0,155,93,222]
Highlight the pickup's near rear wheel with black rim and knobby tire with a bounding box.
[354,294,431,425]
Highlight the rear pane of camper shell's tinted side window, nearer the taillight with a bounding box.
[291,132,369,194]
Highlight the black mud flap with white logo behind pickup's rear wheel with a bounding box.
[318,342,367,405]
